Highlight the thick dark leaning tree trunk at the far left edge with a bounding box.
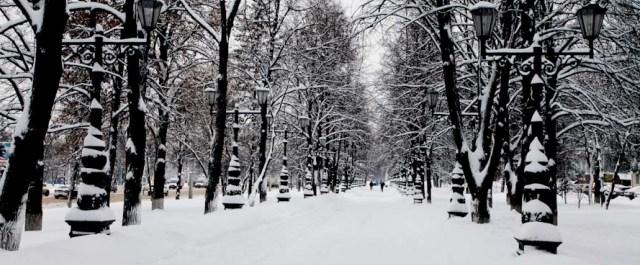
[0,0,67,250]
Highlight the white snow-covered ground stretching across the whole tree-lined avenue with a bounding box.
[0,189,640,265]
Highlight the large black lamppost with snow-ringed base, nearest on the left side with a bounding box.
[62,0,163,237]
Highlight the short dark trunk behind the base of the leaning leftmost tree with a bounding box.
[24,157,44,231]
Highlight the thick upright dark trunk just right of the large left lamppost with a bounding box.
[122,0,147,226]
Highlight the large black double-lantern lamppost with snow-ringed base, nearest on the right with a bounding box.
[471,2,606,253]
